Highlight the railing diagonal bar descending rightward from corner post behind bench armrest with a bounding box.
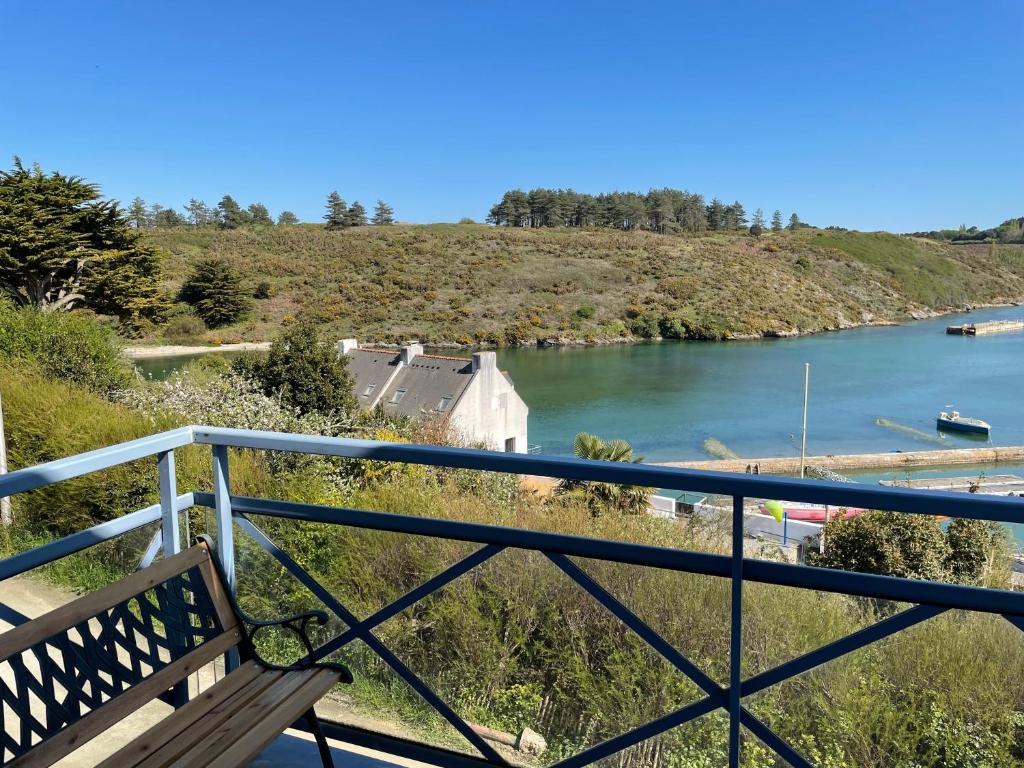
[236,515,508,765]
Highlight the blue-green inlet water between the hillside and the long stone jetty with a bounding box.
[498,307,1024,461]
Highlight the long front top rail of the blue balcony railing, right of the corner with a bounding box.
[193,426,1024,522]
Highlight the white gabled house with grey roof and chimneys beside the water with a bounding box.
[337,339,529,454]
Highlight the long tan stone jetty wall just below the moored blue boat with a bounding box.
[660,445,1024,475]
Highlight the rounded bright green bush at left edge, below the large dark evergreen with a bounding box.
[0,301,133,393]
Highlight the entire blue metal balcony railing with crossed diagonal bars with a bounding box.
[0,427,1024,768]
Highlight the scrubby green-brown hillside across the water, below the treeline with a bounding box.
[140,224,1024,344]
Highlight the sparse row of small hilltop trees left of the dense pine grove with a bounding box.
[128,191,394,229]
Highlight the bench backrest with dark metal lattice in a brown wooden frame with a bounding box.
[0,543,241,766]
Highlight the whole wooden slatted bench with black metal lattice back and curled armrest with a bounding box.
[0,540,352,768]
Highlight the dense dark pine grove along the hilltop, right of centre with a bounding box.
[487,188,806,233]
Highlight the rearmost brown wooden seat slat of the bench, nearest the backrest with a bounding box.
[96,662,266,768]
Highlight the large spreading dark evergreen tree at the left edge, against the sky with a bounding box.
[0,158,167,325]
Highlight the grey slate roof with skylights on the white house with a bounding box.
[348,348,473,416]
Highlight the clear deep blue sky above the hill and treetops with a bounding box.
[0,0,1024,231]
